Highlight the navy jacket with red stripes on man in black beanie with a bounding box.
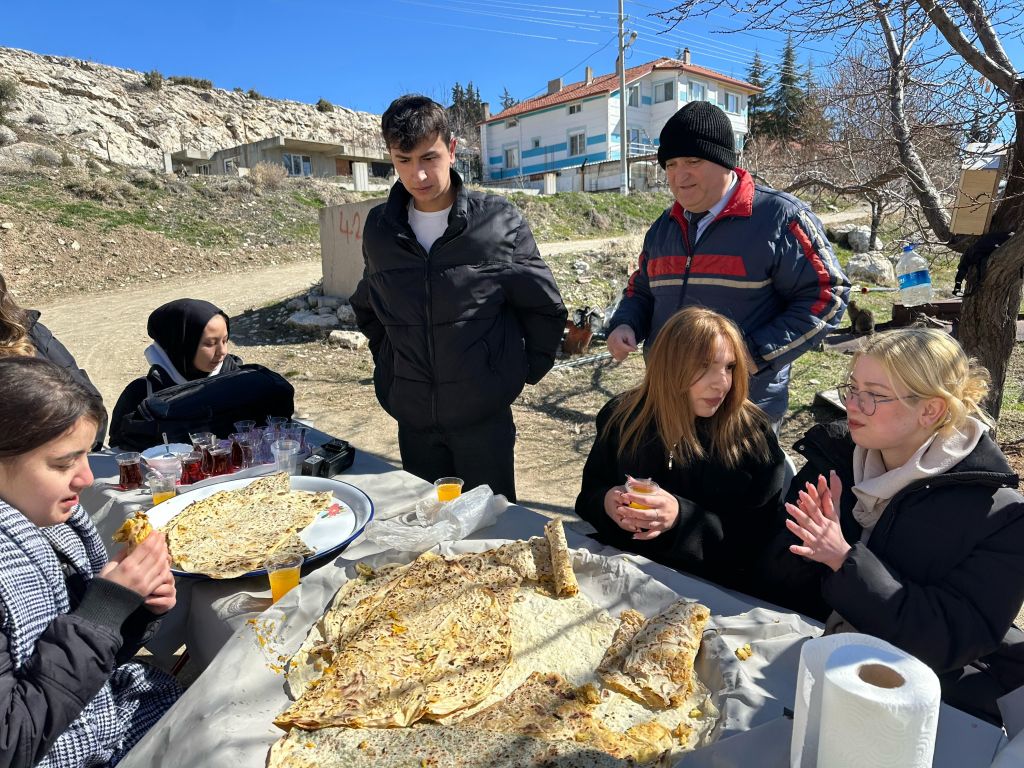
[608,168,850,420]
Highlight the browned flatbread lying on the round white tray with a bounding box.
[164,472,334,579]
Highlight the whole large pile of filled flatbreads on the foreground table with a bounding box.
[267,522,716,768]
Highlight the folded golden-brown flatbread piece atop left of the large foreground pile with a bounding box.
[274,556,515,729]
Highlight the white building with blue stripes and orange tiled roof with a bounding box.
[479,51,760,191]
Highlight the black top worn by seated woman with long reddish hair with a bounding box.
[575,397,784,595]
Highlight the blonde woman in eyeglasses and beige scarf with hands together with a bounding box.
[768,329,1024,723]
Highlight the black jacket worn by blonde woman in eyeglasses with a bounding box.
[768,422,1024,716]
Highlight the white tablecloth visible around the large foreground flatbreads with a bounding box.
[105,455,1001,768]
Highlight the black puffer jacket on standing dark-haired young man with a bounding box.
[351,171,566,429]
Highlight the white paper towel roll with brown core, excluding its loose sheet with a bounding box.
[818,645,941,768]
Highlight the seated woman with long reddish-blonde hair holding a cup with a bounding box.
[575,307,784,593]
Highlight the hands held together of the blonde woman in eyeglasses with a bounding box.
[785,471,851,570]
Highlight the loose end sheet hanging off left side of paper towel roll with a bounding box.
[790,632,929,768]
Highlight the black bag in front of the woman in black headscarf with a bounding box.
[118,364,295,451]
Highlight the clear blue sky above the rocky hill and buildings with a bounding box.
[0,0,1024,113]
